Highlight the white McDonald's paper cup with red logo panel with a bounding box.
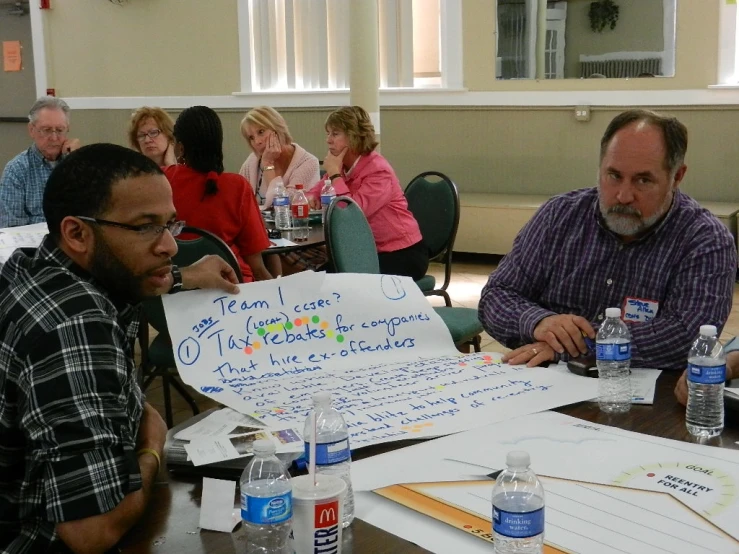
[291,475,346,554]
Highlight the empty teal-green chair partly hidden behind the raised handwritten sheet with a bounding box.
[324,196,482,352]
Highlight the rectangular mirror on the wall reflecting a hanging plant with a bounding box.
[496,0,677,79]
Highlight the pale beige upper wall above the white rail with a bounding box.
[39,0,719,96]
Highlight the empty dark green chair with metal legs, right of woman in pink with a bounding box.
[405,171,459,307]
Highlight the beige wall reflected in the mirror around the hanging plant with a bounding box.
[565,0,664,78]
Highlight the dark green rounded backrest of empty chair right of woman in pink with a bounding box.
[405,171,459,259]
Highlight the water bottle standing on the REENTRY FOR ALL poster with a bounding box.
[493,450,544,554]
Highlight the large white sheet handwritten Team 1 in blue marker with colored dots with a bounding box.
[164,272,597,447]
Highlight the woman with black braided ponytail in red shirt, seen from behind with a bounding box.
[164,106,272,283]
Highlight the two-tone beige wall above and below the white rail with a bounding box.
[0,0,739,205]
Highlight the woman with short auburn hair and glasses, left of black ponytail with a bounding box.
[128,106,177,167]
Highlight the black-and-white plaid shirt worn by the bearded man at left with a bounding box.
[0,237,143,553]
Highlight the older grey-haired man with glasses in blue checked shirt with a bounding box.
[0,96,80,227]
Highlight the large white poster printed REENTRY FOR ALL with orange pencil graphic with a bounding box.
[352,412,739,554]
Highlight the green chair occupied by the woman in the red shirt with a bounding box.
[139,227,243,427]
